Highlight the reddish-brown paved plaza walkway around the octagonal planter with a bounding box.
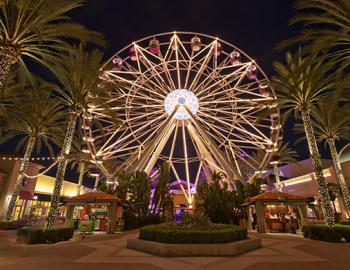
[0,231,350,270]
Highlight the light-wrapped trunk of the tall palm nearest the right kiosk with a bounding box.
[301,109,335,227]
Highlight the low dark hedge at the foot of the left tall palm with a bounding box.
[17,228,74,244]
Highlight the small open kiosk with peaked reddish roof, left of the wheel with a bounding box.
[65,191,122,233]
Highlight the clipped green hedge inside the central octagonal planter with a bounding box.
[139,224,247,244]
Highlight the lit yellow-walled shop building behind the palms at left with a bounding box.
[0,157,90,222]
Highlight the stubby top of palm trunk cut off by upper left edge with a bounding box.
[0,44,21,88]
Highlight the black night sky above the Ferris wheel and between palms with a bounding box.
[1,0,340,186]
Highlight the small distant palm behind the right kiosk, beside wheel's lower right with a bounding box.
[270,141,298,191]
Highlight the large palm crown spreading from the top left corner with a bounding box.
[0,0,105,87]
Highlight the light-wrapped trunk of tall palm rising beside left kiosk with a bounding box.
[46,112,78,229]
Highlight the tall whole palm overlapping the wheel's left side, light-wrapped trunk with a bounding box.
[47,46,103,228]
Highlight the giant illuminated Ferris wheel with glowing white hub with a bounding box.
[84,32,280,205]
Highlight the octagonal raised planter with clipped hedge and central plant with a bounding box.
[127,213,261,257]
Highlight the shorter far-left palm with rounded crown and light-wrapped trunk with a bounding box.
[3,79,66,221]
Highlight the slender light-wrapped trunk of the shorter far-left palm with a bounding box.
[5,137,35,221]
